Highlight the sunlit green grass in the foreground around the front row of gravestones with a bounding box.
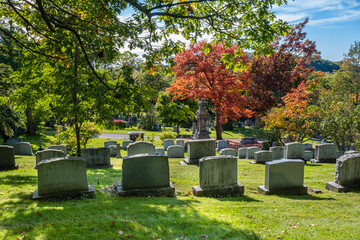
[0,153,360,240]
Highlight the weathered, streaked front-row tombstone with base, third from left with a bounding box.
[192,156,244,197]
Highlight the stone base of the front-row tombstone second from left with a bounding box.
[115,182,175,197]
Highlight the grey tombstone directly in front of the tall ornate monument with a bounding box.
[183,139,216,164]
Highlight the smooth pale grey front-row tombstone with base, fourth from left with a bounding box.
[258,159,307,195]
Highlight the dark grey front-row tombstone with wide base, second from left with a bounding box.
[116,154,175,197]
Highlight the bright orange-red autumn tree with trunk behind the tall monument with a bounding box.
[168,42,252,139]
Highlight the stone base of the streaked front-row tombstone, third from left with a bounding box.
[192,183,244,197]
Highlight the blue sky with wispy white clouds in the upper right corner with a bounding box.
[273,0,360,61]
